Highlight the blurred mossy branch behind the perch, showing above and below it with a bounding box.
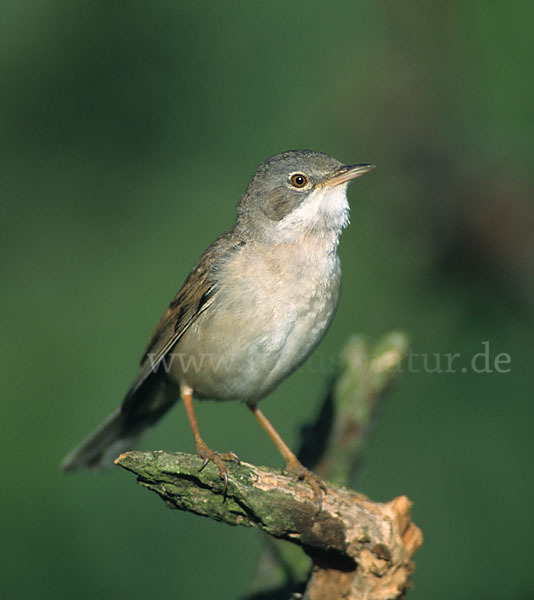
[247,331,409,600]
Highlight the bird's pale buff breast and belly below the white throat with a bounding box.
[177,237,341,402]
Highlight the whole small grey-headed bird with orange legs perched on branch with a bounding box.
[62,150,374,502]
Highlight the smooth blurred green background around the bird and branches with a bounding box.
[0,0,534,600]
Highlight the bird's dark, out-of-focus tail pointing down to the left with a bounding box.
[61,381,177,471]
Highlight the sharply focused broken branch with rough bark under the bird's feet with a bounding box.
[116,452,422,600]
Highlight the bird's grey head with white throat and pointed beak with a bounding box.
[236,150,373,240]
